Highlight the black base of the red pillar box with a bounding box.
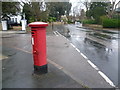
[34,64,48,74]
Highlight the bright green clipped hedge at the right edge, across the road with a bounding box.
[102,18,120,28]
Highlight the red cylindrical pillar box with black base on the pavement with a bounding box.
[29,22,48,74]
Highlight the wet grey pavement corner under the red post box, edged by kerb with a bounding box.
[2,46,82,88]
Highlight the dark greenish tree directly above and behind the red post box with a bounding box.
[21,0,48,21]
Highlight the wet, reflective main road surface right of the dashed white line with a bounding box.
[55,25,120,86]
